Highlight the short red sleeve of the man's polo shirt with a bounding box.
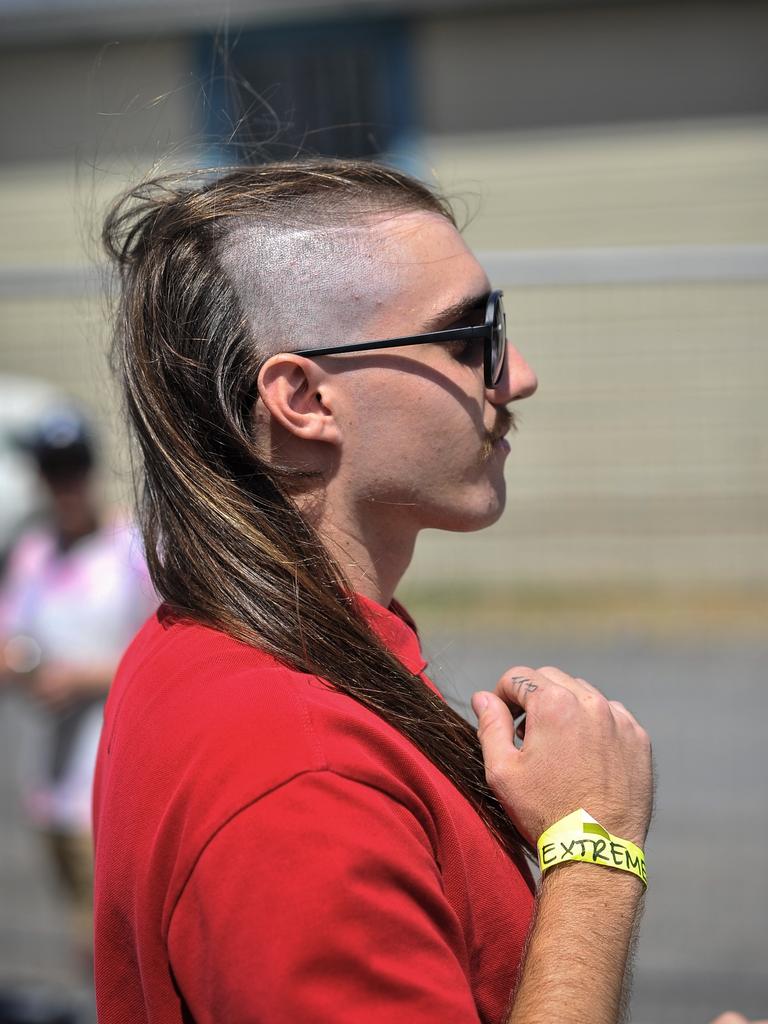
[168,770,479,1024]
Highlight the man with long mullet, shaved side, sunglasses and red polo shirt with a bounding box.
[94,155,652,1024]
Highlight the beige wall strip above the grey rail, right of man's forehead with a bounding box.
[425,116,768,249]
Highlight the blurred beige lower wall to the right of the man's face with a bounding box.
[422,119,768,585]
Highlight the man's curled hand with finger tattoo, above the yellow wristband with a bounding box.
[472,667,653,846]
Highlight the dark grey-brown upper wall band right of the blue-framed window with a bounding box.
[419,0,768,134]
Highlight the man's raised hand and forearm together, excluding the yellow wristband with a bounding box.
[472,668,653,1024]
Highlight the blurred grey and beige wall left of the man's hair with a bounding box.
[0,31,202,502]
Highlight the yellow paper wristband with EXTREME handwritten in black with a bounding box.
[538,808,648,886]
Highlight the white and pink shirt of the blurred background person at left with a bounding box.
[0,520,158,830]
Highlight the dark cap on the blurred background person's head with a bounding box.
[19,407,95,482]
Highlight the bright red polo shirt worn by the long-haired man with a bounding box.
[94,599,532,1024]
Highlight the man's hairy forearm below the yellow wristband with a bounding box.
[506,862,644,1024]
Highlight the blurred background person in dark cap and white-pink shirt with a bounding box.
[0,407,157,978]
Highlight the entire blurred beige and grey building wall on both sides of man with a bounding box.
[0,0,768,586]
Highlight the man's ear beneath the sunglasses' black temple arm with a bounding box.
[258,352,341,444]
